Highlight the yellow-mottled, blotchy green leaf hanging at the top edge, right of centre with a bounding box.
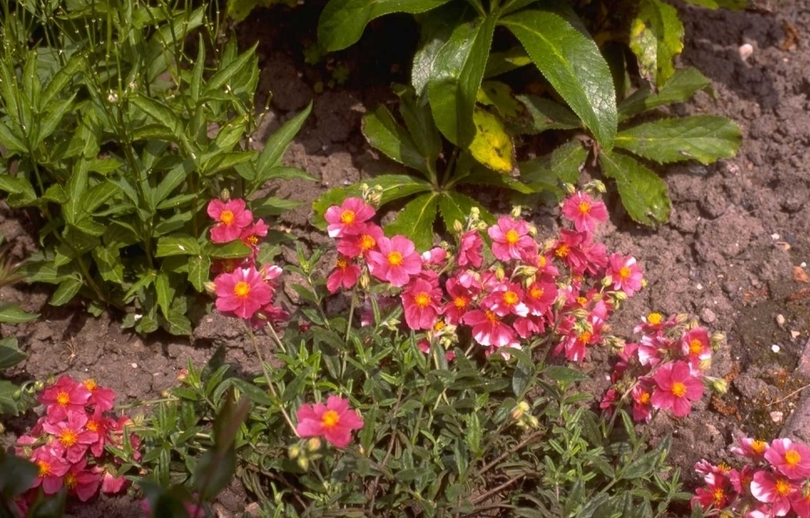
[629,0,684,86]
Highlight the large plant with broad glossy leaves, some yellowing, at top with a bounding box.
[318,0,744,230]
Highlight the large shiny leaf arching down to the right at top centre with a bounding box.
[498,1,618,149]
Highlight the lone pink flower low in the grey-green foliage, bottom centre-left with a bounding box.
[295,396,363,448]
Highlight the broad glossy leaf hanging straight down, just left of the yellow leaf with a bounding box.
[428,16,496,147]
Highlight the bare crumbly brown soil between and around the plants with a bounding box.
[0,0,810,516]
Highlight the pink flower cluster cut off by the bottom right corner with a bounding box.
[692,437,810,518]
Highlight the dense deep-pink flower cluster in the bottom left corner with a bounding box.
[16,376,140,510]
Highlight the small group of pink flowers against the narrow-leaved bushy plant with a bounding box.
[208,199,289,328]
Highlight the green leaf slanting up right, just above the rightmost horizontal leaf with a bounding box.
[619,67,712,121]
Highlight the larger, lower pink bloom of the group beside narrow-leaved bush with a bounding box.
[214,266,273,319]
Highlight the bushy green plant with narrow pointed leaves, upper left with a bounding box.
[0,0,310,334]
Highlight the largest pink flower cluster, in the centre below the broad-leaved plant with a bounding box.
[325,192,643,361]
